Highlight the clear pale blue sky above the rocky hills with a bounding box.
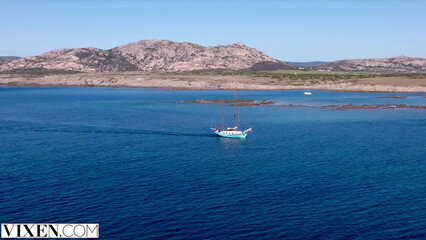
[0,0,426,61]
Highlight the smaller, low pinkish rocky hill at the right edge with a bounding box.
[314,56,426,73]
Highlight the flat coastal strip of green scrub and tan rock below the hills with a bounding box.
[0,68,426,92]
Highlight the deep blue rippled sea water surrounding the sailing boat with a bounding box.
[0,87,426,239]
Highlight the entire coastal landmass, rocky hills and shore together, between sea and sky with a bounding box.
[0,40,426,92]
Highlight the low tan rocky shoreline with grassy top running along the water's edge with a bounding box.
[0,72,426,93]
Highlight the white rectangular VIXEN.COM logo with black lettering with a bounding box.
[1,223,99,238]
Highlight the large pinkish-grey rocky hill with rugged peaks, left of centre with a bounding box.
[0,40,281,72]
